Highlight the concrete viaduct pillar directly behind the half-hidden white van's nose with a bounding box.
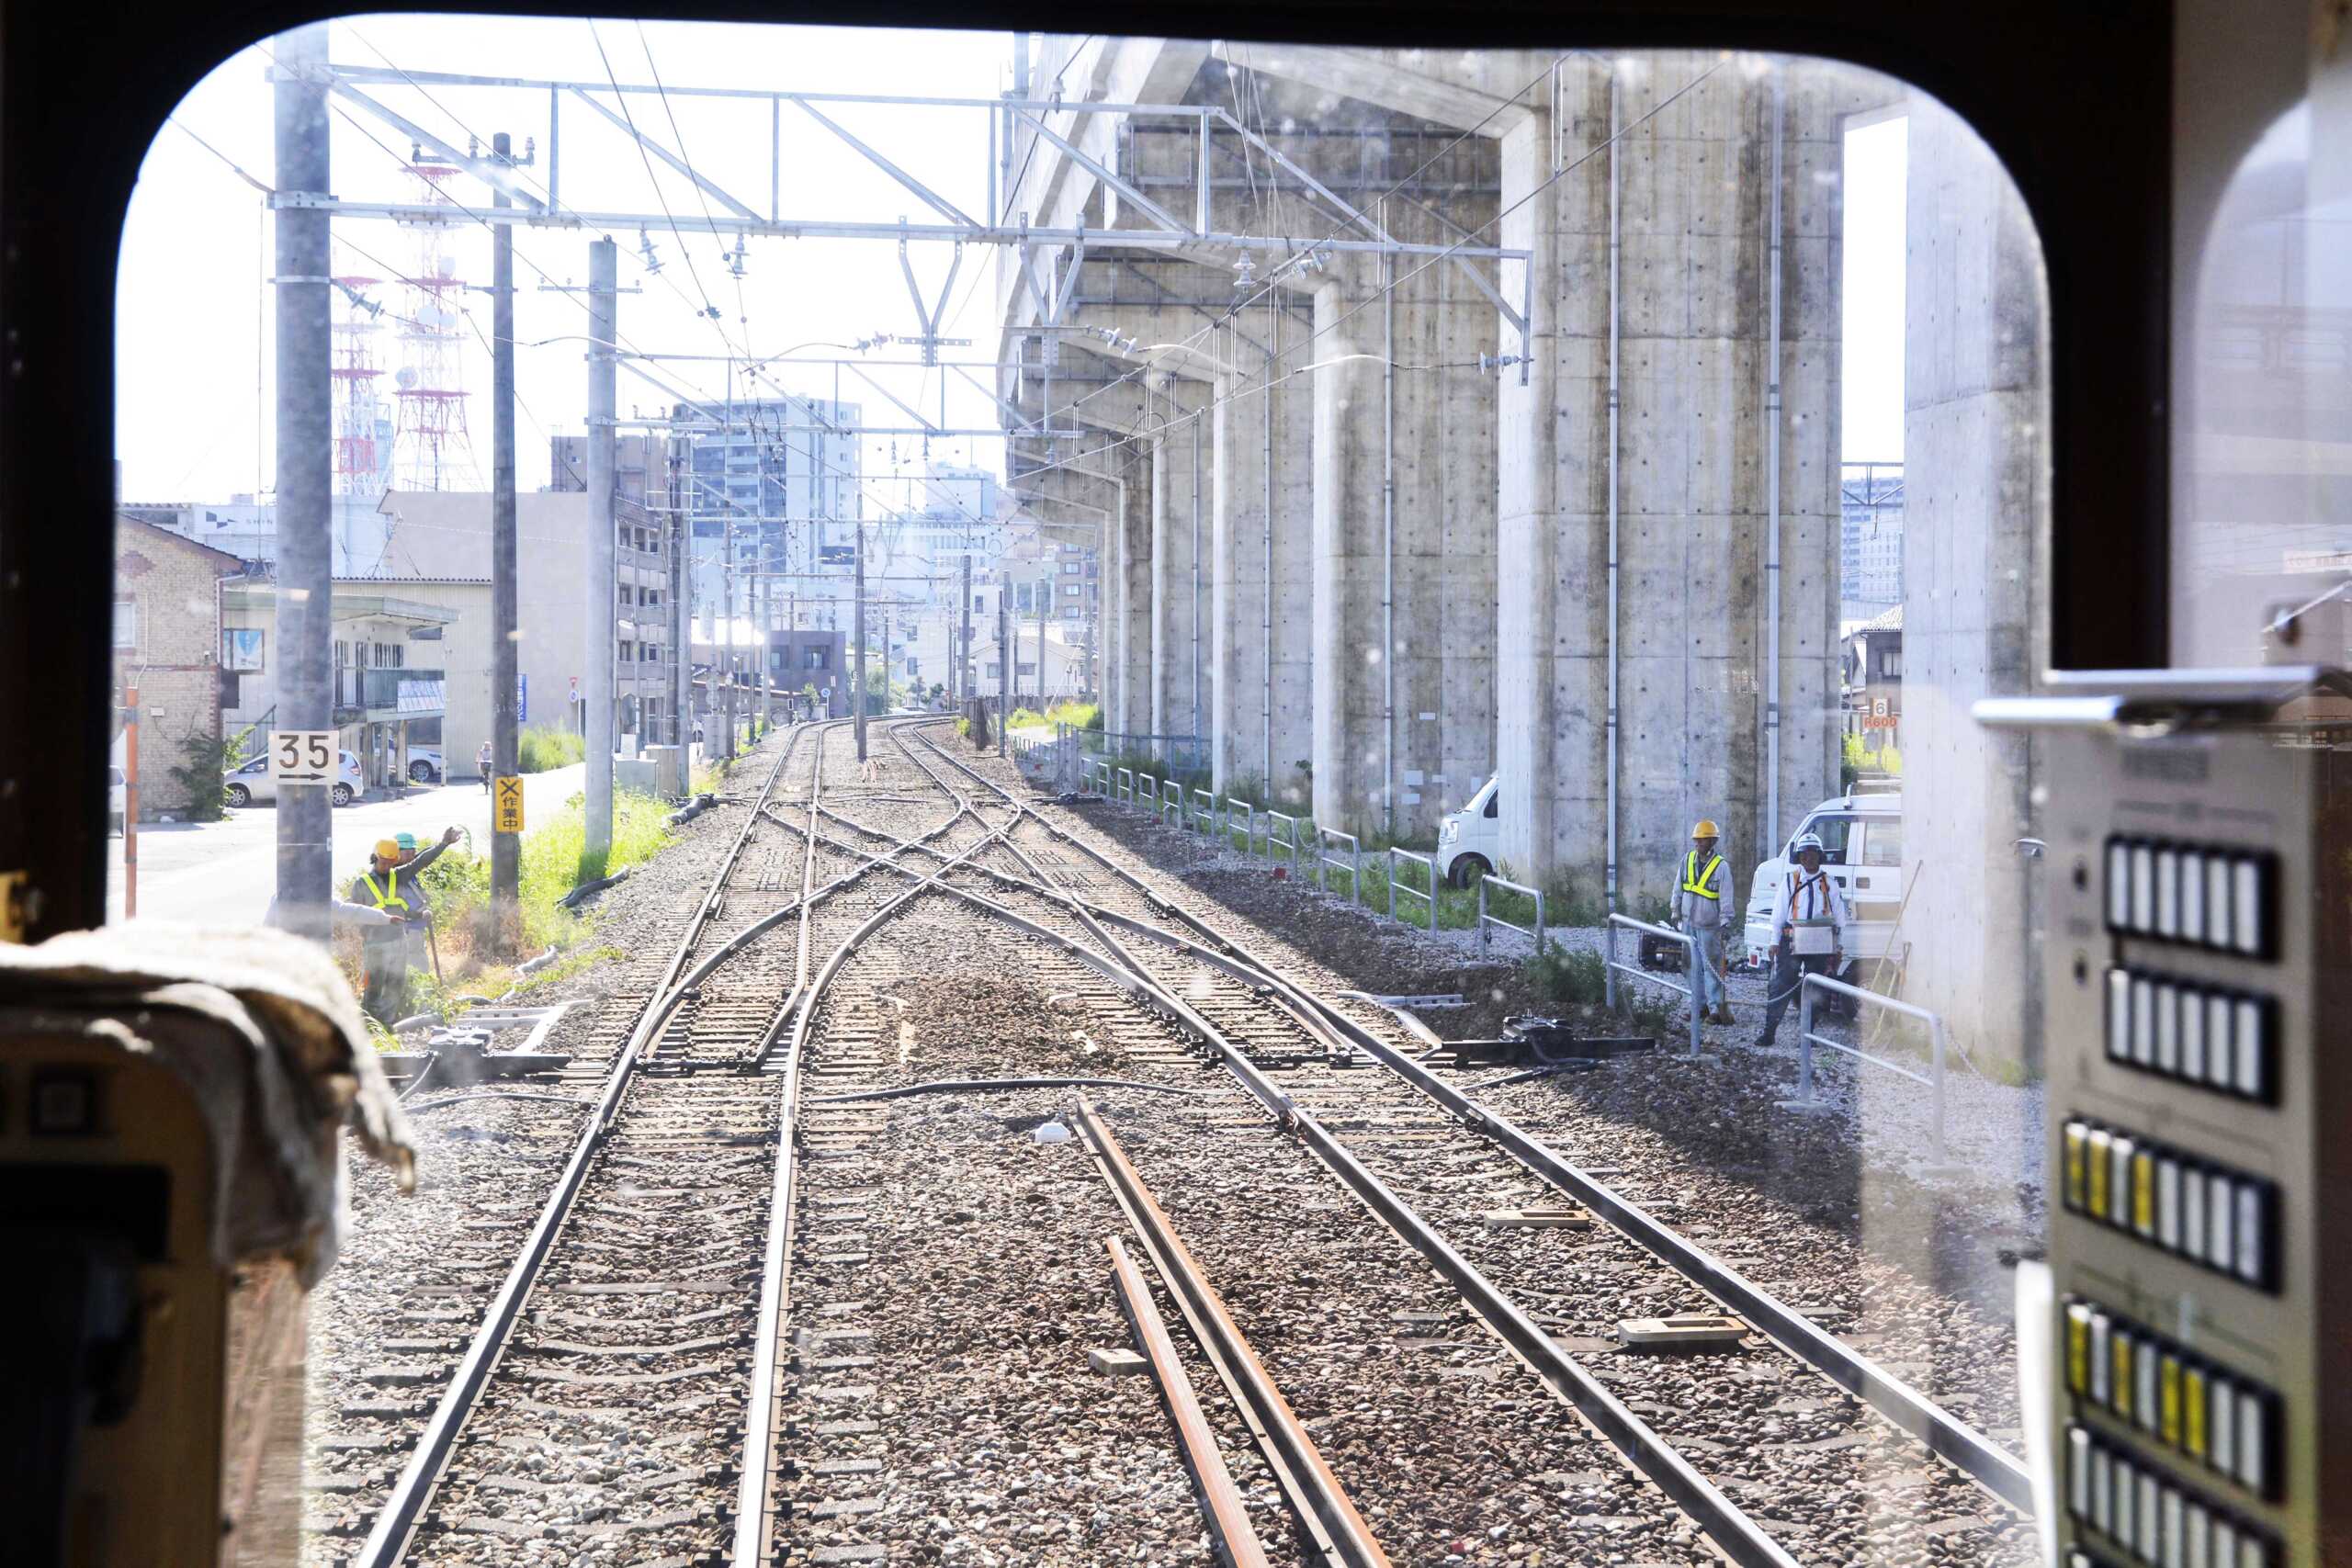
[1312,197,1500,835]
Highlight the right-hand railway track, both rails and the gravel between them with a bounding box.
[790,736,2030,1563]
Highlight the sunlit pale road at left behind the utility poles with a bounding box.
[106,761,588,926]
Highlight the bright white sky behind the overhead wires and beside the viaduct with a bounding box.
[115,17,1905,502]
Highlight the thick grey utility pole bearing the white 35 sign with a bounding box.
[273,24,334,942]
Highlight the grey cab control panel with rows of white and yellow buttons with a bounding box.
[1975,668,2352,1568]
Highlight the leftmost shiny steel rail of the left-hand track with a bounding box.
[353,728,807,1568]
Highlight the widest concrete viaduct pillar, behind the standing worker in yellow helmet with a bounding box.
[1496,54,1858,905]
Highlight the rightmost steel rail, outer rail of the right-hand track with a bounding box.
[920,736,2032,1514]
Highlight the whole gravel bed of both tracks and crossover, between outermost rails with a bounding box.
[326,722,2032,1568]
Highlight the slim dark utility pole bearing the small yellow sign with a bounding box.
[489,131,522,954]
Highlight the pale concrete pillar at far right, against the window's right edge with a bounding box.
[1903,98,2051,1055]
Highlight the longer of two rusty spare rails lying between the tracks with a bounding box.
[1077,1096,1387,1568]
